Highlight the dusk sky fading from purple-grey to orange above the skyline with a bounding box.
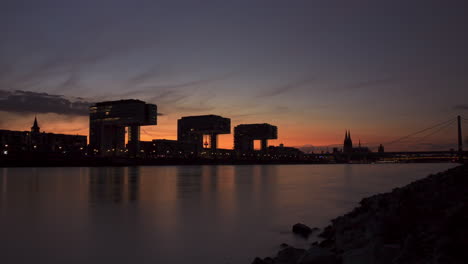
[0,0,468,150]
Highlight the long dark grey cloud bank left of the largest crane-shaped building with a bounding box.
[0,90,91,116]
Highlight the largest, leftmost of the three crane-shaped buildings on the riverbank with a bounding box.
[89,99,157,157]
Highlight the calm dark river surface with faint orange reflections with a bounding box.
[0,164,455,264]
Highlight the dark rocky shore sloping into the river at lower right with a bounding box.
[252,165,468,264]
